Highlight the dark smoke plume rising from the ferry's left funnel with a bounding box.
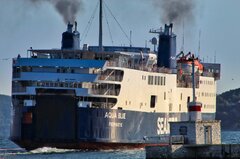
[27,0,83,23]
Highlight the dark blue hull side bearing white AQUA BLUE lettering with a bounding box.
[77,108,215,143]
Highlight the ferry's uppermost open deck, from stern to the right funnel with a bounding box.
[26,47,157,71]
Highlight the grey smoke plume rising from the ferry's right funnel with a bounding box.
[153,0,195,25]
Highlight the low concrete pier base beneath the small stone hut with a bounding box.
[145,144,240,159]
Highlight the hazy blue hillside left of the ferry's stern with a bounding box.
[0,95,11,138]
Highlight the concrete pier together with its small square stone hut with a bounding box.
[145,120,240,159]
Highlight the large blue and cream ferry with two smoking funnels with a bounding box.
[11,0,220,150]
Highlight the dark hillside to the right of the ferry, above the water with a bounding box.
[216,88,240,131]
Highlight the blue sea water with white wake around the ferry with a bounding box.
[0,131,240,159]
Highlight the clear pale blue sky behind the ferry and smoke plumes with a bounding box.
[0,0,240,95]
